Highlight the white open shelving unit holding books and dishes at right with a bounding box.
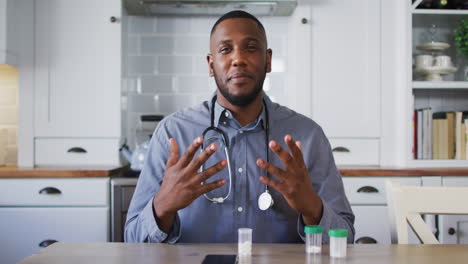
[406,0,468,168]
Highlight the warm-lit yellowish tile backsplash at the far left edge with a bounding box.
[0,64,18,164]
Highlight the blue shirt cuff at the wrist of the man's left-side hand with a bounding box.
[140,199,181,244]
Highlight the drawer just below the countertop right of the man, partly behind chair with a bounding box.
[343,177,421,204]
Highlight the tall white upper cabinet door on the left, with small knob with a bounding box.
[35,0,121,137]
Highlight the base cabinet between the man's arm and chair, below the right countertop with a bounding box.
[343,177,421,244]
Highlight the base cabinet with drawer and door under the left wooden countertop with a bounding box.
[0,177,110,264]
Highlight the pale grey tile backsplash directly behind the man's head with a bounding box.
[122,16,288,148]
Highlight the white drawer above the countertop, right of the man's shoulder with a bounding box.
[329,138,380,165]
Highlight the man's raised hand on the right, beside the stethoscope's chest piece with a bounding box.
[257,135,323,225]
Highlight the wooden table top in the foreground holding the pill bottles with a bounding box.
[16,243,468,264]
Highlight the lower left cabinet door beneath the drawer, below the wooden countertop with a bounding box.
[0,207,109,264]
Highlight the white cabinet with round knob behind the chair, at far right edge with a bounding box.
[439,177,468,244]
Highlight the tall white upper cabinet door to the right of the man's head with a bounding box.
[311,0,380,138]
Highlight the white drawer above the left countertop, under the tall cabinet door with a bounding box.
[34,138,120,166]
